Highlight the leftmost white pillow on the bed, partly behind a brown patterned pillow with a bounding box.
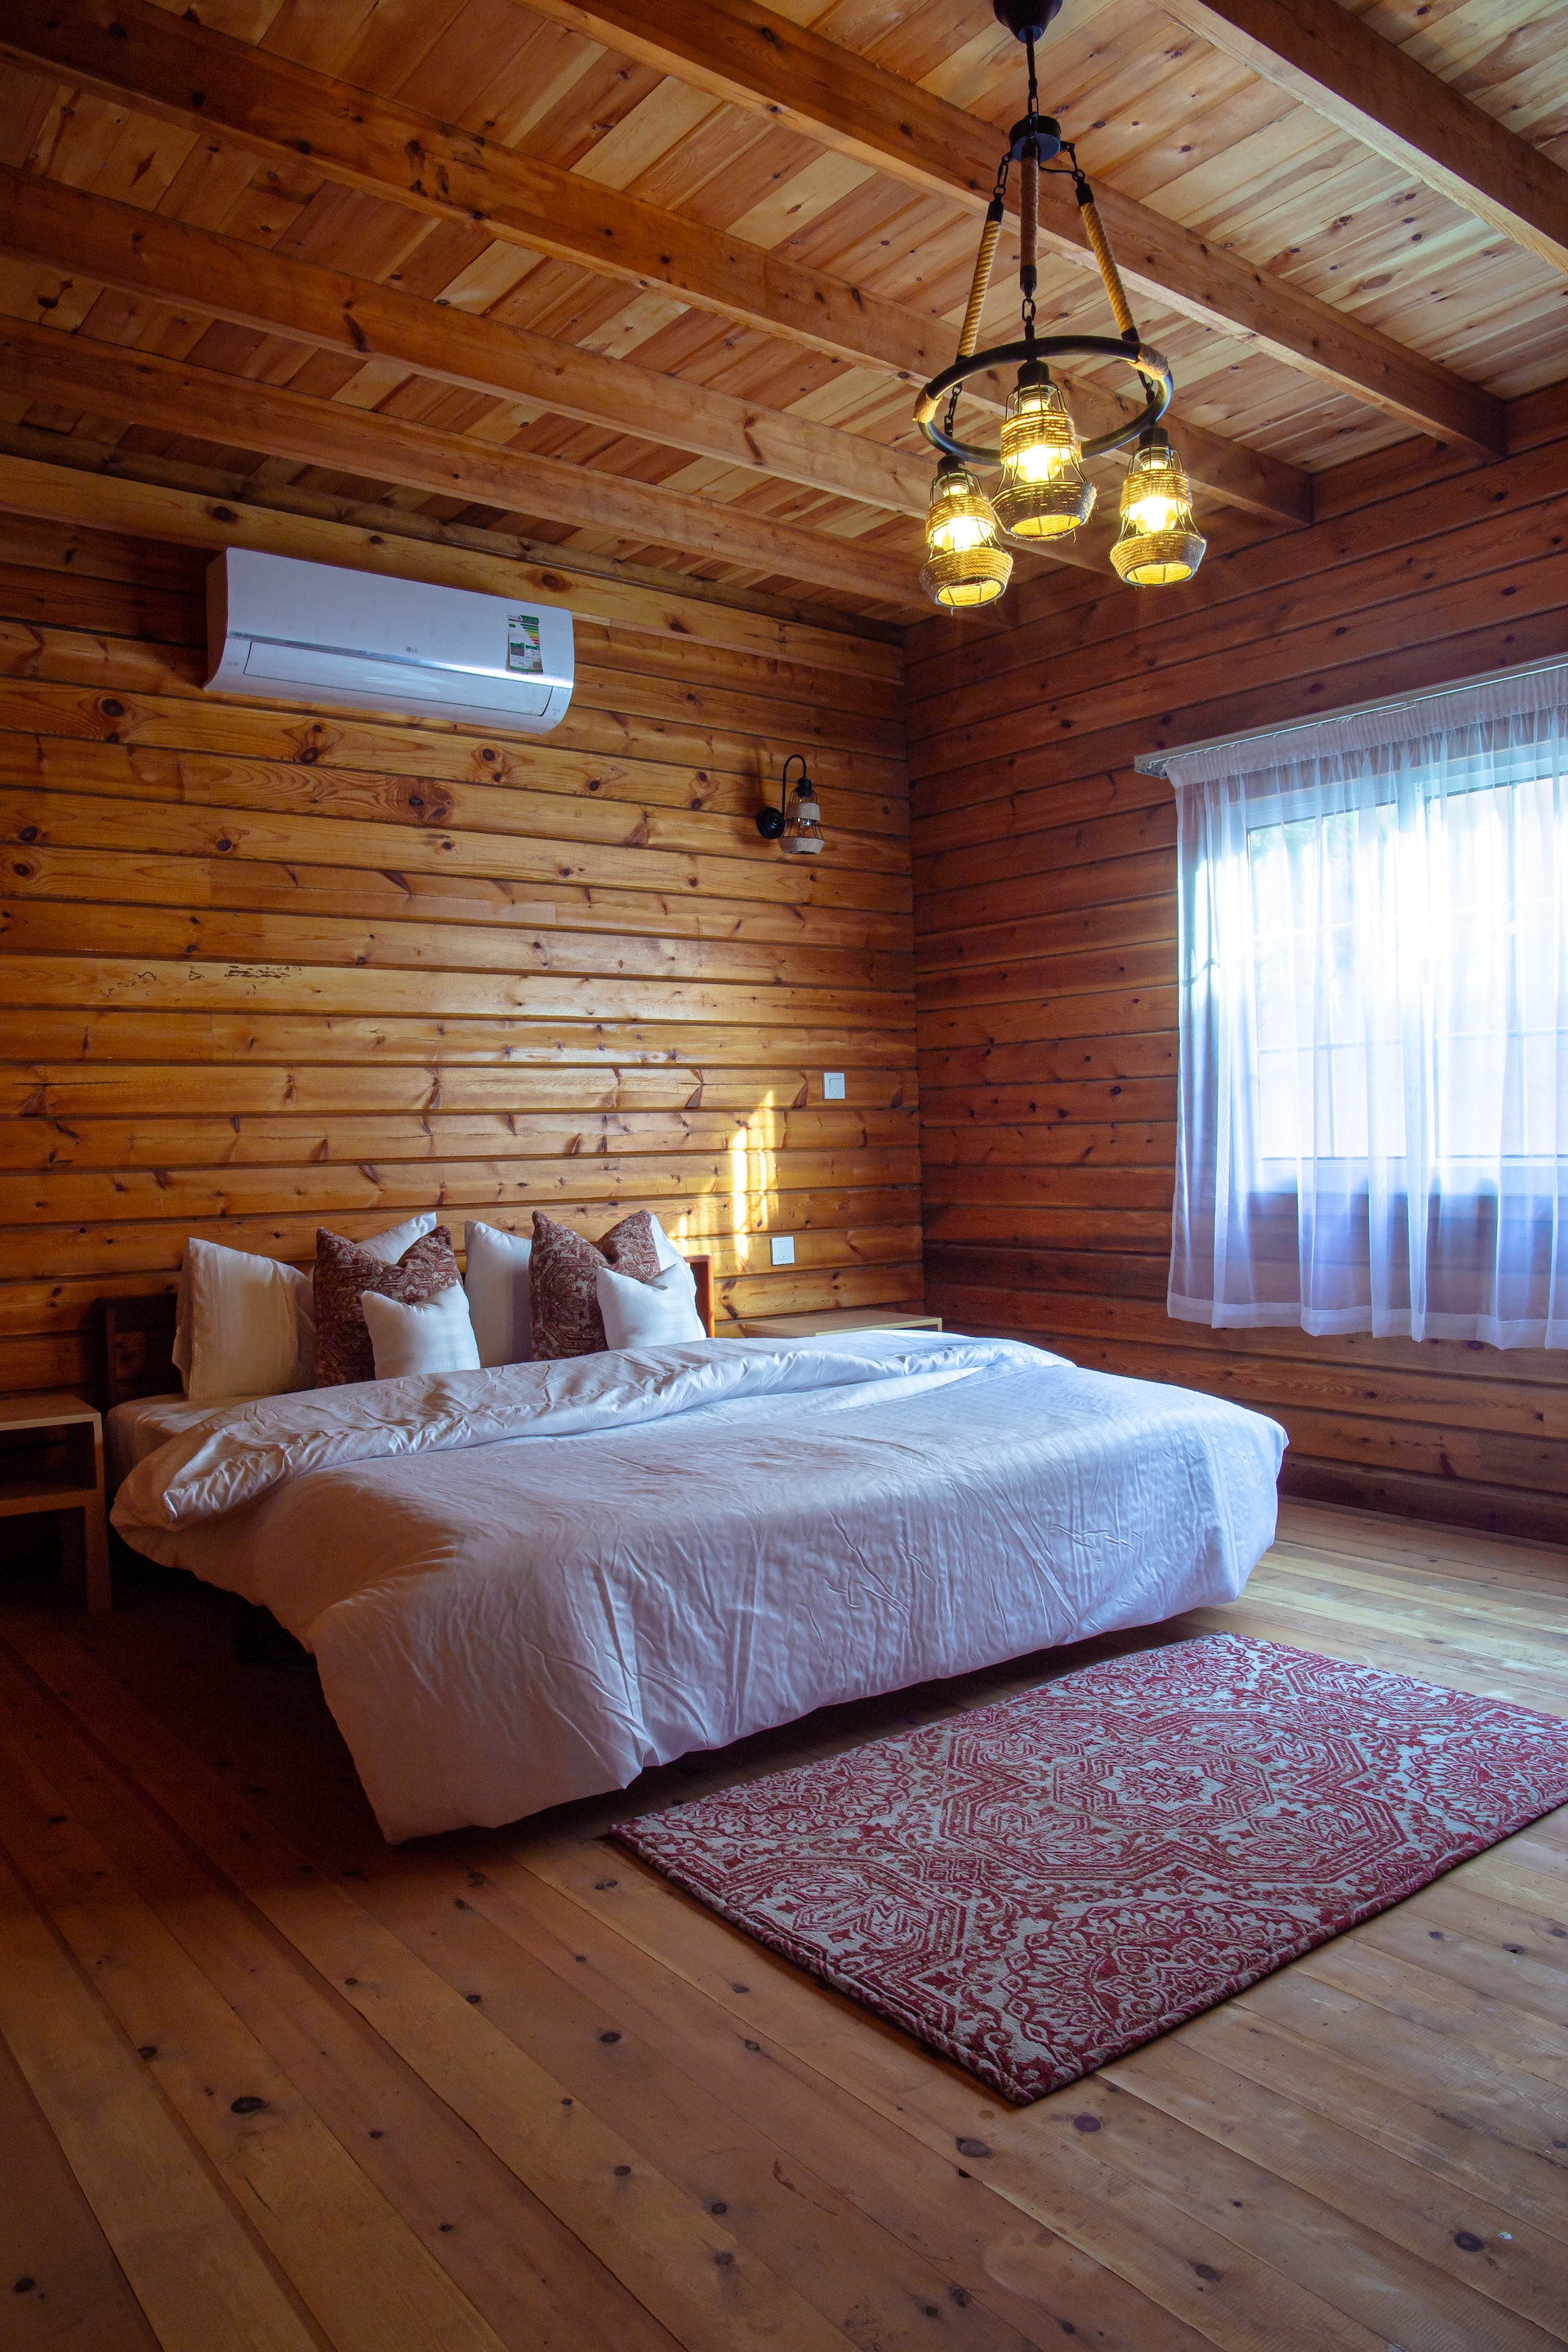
[174,1240,315,1404]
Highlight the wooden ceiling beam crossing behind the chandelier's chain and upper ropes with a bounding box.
[514,0,1507,457]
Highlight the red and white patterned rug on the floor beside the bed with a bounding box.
[613,1635,1568,2105]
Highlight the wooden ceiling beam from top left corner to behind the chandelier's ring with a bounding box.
[0,0,1312,524]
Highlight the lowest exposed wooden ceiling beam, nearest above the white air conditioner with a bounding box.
[0,320,921,607]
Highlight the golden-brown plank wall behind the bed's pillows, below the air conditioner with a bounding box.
[0,518,921,1392]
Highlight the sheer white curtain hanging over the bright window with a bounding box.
[1166,668,1568,1348]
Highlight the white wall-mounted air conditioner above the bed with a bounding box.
[207,548,573,734]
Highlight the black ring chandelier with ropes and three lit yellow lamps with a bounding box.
[915,0,1206,612]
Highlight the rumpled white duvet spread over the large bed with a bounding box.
[113,1334,1284,1839]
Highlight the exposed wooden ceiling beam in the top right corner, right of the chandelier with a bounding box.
[1161,0,1568,270]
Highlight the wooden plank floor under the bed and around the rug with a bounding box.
[0,1503,1568,2352]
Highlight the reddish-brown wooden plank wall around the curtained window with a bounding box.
[907,388,1568,1539]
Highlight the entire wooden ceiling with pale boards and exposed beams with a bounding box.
[0,0,1568,621]
